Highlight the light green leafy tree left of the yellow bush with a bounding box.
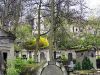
[15,24,34,51]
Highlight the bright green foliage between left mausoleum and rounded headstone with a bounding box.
[7,58,40,75]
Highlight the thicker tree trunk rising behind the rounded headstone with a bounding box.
[49,0,55,61]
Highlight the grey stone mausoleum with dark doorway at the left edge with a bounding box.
[0,29,15,75]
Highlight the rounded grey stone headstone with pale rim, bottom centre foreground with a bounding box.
[37,61,67,75]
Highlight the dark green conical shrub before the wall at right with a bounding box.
[82,57,93,70]
